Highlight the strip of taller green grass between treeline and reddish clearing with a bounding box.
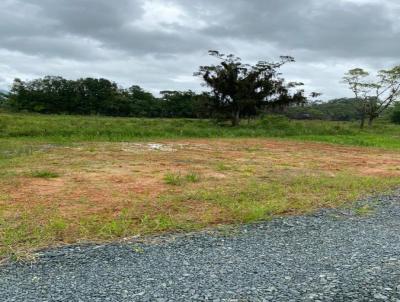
[0,113,400,149]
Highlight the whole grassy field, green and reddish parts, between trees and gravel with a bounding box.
[0,114,400,257]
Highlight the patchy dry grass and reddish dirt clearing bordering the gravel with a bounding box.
[0,139,400,256]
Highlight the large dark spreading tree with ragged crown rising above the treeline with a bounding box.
[194,51,305,126]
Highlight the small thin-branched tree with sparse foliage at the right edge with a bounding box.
[343,65,400,128]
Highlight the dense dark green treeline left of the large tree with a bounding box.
[0,76,212,118]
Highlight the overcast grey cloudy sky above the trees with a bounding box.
[0,0,400,99]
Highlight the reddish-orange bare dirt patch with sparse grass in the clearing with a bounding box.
[7,139,400,206]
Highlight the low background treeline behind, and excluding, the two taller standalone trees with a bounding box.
[0,76,400,124]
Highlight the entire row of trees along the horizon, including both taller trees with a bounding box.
[0,50,400,128]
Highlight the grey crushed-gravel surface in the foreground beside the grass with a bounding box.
[0,192,400,302]
